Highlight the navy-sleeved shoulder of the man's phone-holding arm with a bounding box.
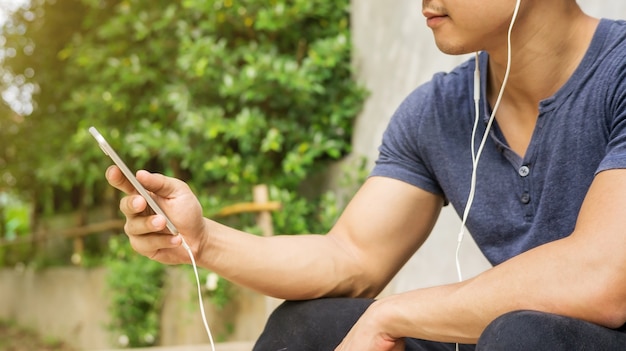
[372,59,474,194]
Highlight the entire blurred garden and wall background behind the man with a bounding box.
[0,0,626,350]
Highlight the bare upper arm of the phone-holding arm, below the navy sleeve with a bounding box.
[328,177,443,296]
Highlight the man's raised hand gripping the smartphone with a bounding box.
[106,166,206,264]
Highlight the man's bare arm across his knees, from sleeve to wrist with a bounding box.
[372,170,626,342]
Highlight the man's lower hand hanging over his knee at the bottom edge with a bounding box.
[335,301,404,351]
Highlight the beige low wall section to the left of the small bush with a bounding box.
[0,267,109,349]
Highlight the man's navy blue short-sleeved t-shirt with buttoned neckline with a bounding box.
[371,19,626,265]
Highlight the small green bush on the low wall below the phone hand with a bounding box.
[106,237,165,347]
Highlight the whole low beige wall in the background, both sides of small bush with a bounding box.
[0,266,271,350]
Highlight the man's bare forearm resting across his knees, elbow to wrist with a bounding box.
[370,235,624,343]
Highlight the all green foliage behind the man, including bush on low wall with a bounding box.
[0,0,365,345]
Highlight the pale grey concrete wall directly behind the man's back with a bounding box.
[352,0,626,292]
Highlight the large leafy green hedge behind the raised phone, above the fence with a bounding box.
[3,0,364,212]
